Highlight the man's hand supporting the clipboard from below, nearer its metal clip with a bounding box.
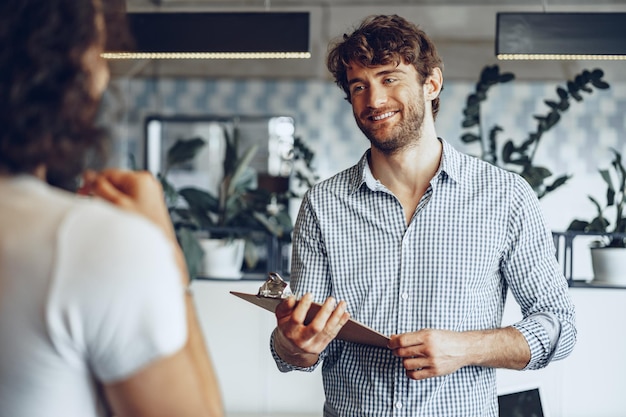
[275,293,350,367]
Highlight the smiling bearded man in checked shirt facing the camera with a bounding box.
[271,16,576,417]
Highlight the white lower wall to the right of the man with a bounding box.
[498,288,626,417]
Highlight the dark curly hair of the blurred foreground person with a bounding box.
[0,0,129,188]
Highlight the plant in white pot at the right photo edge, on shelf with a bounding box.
[567,149,626,285]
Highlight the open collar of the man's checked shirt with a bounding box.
[351,138,461,192]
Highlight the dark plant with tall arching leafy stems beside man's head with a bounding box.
[461,65,609,198]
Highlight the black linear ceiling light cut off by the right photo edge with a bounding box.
[496,13,626,60]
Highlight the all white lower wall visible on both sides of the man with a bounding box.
[193,281,626,417]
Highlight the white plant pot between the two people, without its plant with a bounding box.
[199,239,246,279]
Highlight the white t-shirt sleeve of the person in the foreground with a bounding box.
[50,204,187,383]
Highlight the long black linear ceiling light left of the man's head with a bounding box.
[102,12,311,59]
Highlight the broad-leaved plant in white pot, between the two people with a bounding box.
[159,125,312,278]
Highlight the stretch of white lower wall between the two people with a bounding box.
[193,280,324,417]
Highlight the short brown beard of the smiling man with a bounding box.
[355,100,424,155]
